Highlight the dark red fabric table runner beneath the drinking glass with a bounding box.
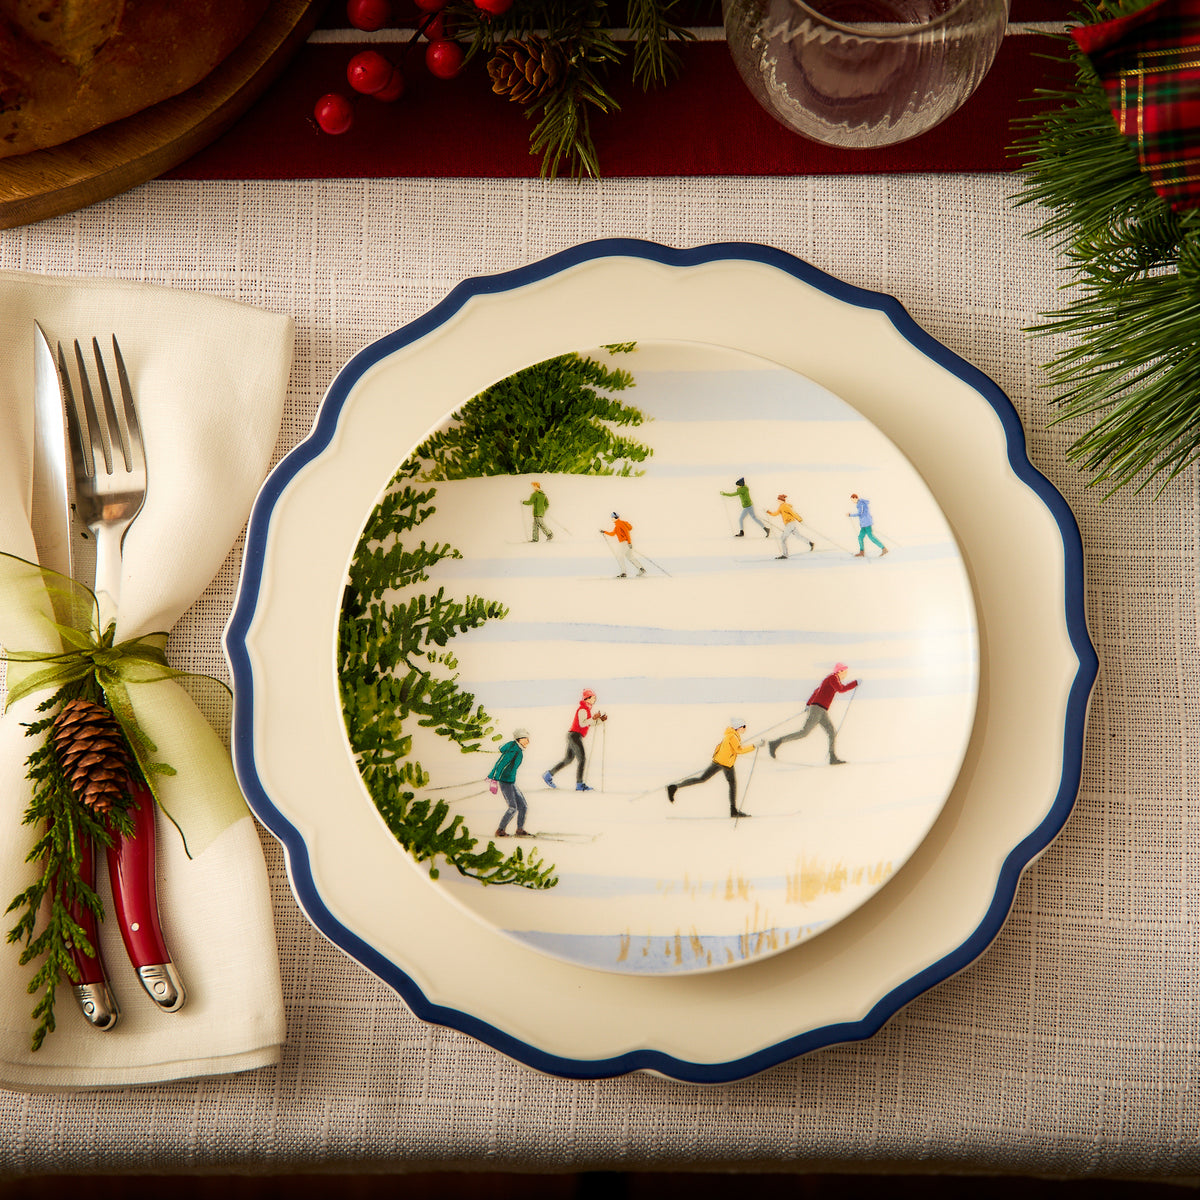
[168,0,1070,179]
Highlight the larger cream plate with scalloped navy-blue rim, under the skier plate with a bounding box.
[226,241,1096,1082]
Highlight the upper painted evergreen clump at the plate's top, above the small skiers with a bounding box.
[414,342,654,480]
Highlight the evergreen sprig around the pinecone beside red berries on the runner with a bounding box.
[445,0,700,179]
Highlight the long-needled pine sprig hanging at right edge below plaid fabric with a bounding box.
[1015,0,1200,494]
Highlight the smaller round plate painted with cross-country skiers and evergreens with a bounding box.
[342,342,978,974]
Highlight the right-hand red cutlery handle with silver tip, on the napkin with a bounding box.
[108,780,185,1013]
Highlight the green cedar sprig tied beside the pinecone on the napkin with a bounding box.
[6,678,133,1050]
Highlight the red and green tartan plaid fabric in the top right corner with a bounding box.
[1070,0,1200,210]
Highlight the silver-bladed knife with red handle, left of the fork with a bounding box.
[30,322,120,1030]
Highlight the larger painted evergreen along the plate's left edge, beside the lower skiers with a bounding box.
[338,480,557,888]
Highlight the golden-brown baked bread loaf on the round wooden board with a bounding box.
[0,0,269,158]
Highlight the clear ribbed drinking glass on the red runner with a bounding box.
[722,0,1008,148]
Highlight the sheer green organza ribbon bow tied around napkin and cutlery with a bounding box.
[0,552,228,857]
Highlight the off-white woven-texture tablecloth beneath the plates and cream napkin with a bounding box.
[0,176,1200,1176]
